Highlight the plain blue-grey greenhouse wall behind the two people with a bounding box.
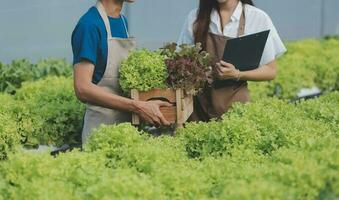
[0,0,339,63]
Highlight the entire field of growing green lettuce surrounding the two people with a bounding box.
[0,39,339,200]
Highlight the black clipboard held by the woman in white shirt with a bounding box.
[214,30,270,88]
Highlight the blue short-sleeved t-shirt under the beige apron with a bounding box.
[72,7,127,84]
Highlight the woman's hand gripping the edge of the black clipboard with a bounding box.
[216,61,240,80]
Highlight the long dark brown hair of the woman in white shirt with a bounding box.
[194,0,254,48]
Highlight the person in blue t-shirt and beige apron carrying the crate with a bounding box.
[72,0,171,142]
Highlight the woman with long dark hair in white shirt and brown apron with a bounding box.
[178,0,286,121]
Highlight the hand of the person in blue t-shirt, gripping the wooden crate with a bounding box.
[135,100,172,126]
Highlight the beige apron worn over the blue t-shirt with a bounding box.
[82,1,135,143]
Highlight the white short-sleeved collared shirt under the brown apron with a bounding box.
[177,1,286,65]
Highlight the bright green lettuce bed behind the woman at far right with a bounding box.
[249,39,339,100]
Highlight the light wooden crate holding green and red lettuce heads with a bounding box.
[131,89,193,127]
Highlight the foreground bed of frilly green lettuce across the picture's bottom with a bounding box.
[0,92,339,199]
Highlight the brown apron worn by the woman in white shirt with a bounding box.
[189,5,250,122]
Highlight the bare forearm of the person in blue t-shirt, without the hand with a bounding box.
[77,84,137,112]
